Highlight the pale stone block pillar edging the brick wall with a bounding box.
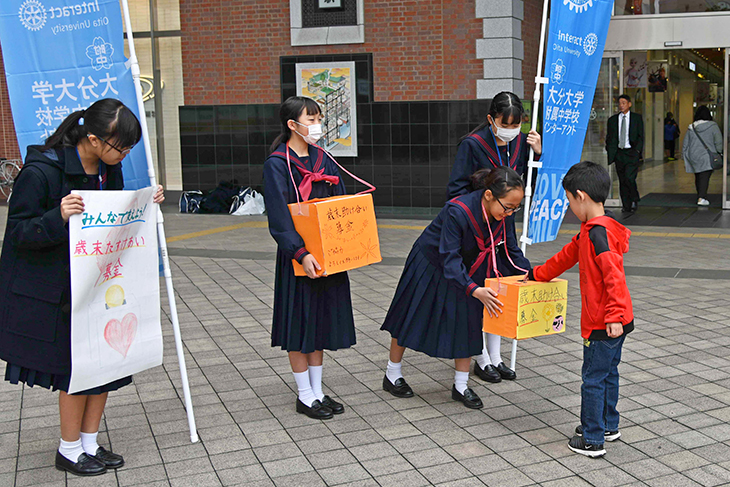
[476,0,525,98]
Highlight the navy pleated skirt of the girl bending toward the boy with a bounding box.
[380,243,484,359]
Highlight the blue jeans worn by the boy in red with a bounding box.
[580,335,626,445]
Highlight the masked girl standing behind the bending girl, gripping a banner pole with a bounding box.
[448,91,542,382]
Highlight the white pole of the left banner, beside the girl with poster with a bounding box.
[121,0,198,443]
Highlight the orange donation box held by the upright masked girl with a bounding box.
[289,194,383,276]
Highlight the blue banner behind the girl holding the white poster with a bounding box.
[0,0,150,189]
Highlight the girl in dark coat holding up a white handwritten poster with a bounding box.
[0,99,164,475]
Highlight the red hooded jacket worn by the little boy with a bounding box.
[530,216,634,340]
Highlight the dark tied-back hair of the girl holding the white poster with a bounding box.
[42,98,142,151]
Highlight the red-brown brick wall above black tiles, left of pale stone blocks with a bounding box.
[180,0,484,105]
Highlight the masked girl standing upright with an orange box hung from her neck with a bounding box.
[264,96,355,419]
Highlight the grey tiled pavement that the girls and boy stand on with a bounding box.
[0,208,730,487]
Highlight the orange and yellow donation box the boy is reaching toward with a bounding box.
[483,276,568,340]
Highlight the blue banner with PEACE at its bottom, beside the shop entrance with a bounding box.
[528,0,613,243]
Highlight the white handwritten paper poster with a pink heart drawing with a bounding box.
[68,187,162,393]
